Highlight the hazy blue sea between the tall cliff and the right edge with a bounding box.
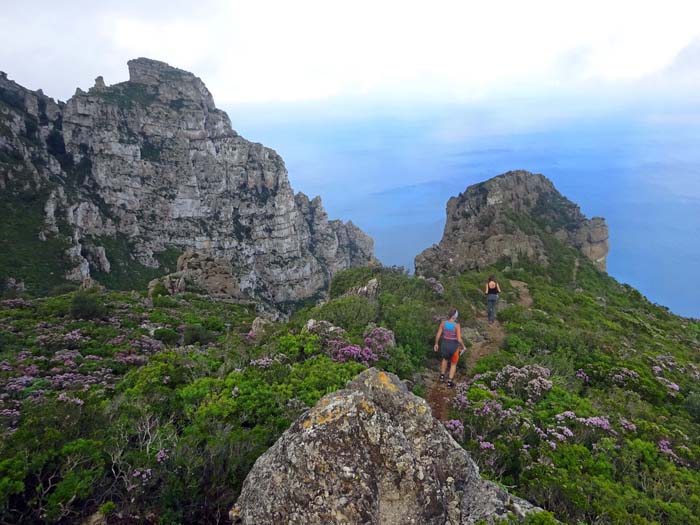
[228,101,700,318]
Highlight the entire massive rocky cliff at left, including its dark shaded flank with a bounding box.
[0,58,373,304]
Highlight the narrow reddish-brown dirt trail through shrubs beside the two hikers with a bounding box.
[423,280,533,421]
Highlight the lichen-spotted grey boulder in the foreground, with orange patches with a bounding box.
[231,369,534,525]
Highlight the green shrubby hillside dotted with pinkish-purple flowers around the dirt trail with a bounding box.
[0,228,700,525]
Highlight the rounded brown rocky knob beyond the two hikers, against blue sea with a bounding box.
[415,171,609,276]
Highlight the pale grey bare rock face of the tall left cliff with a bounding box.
[0,58,373,304]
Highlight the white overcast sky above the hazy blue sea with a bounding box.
[0,0,700,107]
